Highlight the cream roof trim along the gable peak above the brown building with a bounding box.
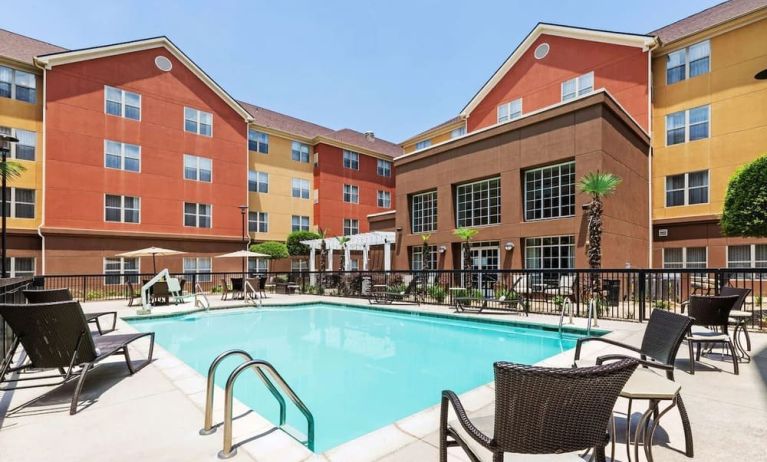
[460,23,656,118]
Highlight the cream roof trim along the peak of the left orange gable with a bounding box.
[34,36,251,121]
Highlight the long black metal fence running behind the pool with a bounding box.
[13,268,767,329]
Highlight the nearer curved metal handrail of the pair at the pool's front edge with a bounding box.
[218,359,314,459]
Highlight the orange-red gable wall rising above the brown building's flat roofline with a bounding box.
[467,34,649,132]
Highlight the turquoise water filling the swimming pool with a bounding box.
[130,303,588,452]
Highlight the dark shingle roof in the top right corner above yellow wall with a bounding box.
[650,0,767,43]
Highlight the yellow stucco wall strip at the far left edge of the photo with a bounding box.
[0,59,43,229]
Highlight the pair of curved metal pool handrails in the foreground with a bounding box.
[200,350,314,459]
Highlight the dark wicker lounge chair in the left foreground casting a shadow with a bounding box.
[0,300,154,415]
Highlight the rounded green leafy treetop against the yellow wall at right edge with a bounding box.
[719,156,767,237]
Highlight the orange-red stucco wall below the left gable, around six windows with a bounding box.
[45,48,248,236]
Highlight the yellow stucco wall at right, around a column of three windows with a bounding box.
[653,13,767,219]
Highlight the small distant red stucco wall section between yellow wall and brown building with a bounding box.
[314,143,394,236]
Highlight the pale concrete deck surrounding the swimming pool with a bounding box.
[0,295,767,462]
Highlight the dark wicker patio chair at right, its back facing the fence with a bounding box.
[685,295,739,375]
